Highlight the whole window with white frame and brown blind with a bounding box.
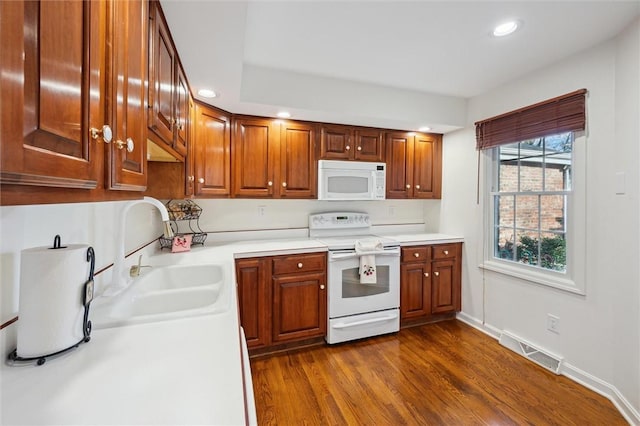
[476,89,587,294]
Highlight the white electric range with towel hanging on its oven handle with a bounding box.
[309,212,400,344]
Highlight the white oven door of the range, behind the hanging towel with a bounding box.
[327,247,400,318]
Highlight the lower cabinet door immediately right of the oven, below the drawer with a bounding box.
[400,262,431,319]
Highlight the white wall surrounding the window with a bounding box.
[439,21,640,421]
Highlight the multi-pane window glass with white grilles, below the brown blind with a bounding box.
[491,132,573,273]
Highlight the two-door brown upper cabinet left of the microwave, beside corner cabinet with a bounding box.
[231,116,317,199]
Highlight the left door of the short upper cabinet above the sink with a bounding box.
[149,2,176,146]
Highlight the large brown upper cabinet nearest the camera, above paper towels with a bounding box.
[0,1,148,193]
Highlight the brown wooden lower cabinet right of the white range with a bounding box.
[400,243,462,324]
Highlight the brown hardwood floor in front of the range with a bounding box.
[251,320,627,425]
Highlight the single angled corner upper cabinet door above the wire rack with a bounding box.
[193,103,231,196]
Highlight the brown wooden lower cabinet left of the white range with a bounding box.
[236,253,327,349]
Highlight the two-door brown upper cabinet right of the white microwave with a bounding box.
[385,132,442,199]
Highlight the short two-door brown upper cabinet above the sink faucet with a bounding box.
[148,0,190,161]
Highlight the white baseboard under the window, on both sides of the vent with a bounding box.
[456,312,640,425]
